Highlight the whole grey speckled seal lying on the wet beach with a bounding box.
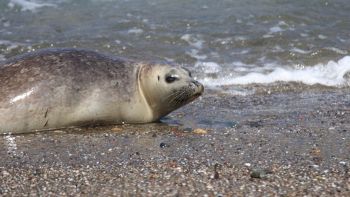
[0,49,204,133]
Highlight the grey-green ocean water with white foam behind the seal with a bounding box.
[0,0,350,94]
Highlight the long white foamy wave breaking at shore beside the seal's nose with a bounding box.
[202,56,350,87]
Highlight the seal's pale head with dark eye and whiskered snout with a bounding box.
[139,64,204,120]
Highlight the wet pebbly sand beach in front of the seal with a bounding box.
[0,89,350,196]
